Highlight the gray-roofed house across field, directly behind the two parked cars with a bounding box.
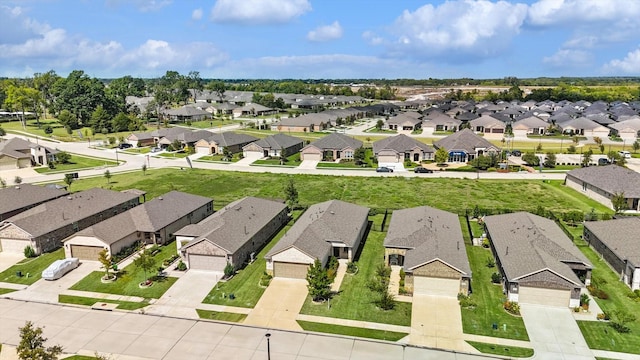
[373,134,435,163]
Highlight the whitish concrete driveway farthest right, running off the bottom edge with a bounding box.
[520,304,594,360]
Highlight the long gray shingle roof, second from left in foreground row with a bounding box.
[7,188,138,237]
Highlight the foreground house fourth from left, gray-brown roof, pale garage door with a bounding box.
[176,197,289,271]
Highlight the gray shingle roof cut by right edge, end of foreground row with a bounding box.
[584,217,640,267]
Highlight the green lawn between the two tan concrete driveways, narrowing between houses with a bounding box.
[300,215,411,326]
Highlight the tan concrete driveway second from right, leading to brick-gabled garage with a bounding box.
[409,295,477,353]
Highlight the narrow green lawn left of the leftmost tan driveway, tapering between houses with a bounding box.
[202,212,300,308]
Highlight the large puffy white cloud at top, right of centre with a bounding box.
[382,0,528,61]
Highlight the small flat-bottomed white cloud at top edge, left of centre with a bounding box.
[211,0,311,24]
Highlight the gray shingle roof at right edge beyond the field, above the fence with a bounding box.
[567,165,640,198]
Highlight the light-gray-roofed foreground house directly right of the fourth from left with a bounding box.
[265,200,369,279]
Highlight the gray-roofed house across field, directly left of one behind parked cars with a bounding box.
[300,133,362,161]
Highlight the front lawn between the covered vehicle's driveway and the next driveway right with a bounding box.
[71,242,178,299]
